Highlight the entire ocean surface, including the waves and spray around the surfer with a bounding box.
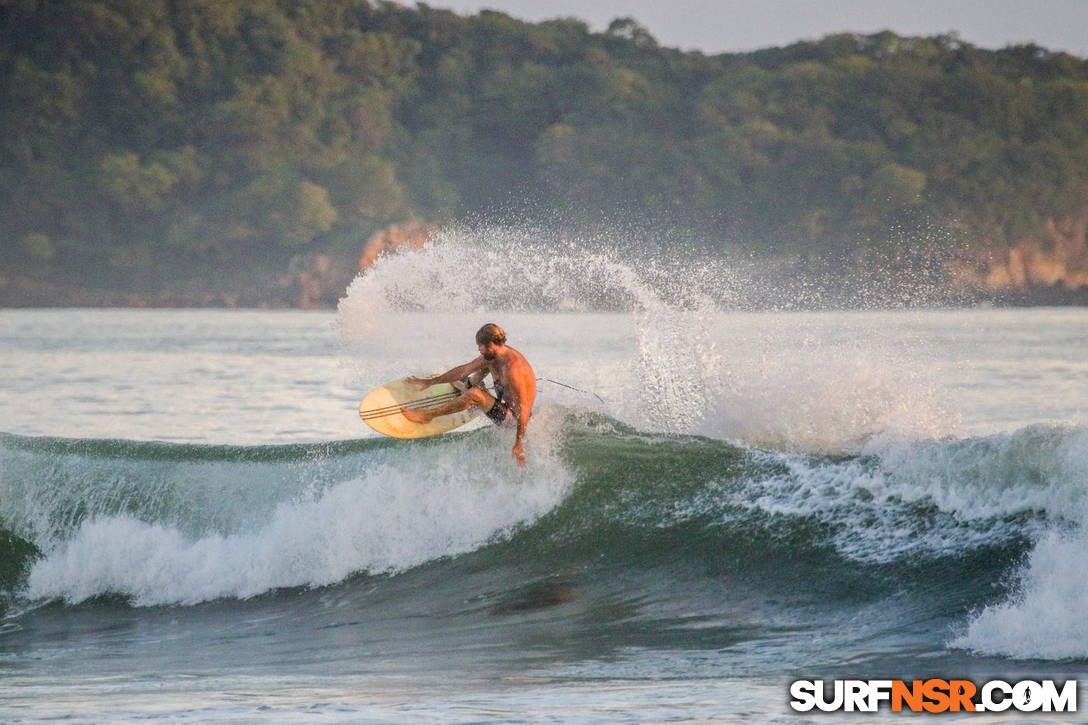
[0,227,1088,723]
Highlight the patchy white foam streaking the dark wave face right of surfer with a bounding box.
[708,427,1086,564]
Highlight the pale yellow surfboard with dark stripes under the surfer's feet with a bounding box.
[359,378,480,438]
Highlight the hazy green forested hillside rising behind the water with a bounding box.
[0,0,1088,304]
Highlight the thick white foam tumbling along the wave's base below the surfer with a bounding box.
[25,428,571,605]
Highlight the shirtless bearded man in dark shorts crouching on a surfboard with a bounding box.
[400,322,536,466]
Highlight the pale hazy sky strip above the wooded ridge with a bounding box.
[428,0,1088,57]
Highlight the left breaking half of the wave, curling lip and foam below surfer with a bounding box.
[0,428,569,605]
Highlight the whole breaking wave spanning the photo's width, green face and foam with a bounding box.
[0,418,1088,658]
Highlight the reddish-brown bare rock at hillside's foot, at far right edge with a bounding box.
[955,208,1088,293]
